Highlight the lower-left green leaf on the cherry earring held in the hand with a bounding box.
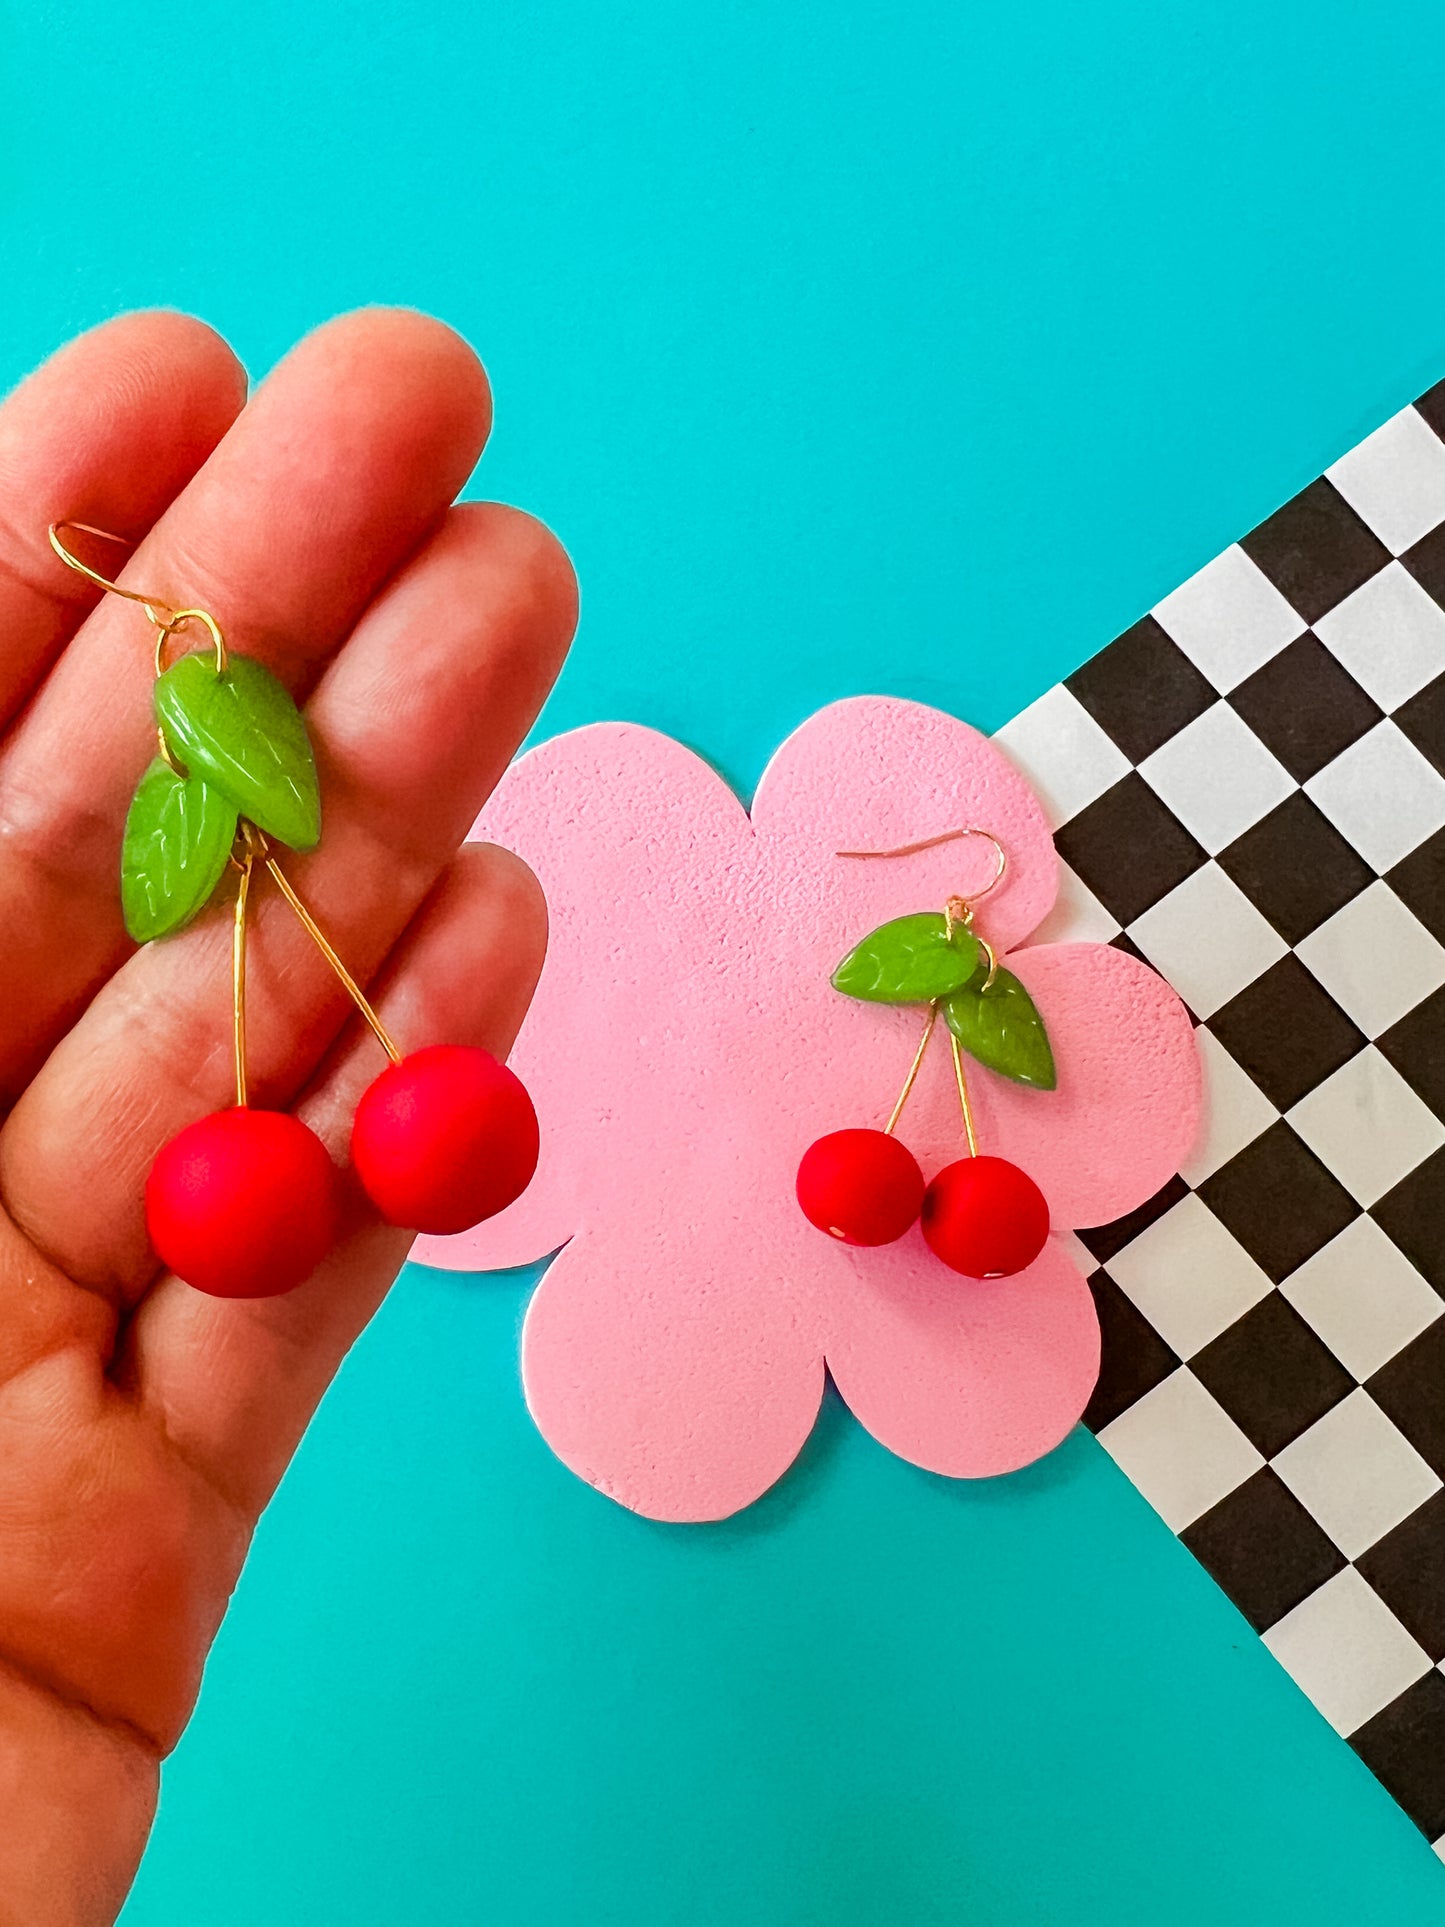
[121,757,235,944]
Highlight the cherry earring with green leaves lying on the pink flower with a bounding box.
[798,825,1058,1278]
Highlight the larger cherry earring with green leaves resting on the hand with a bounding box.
[50,522,538,1299]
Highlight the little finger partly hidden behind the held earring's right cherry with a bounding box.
[119,844,547,1517]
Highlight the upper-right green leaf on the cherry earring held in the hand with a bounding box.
[156,649,322,850]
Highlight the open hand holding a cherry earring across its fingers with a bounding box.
[0,310,576,1927]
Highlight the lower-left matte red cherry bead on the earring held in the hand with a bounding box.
[146,1106,339,1299]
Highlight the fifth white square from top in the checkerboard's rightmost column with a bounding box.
[1285,1044,1445,1210]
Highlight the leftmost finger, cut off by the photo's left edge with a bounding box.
[0,312,247,732]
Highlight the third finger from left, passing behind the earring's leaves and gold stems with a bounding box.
[0,505,576,1303]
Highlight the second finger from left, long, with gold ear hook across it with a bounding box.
[0,310,489,1100]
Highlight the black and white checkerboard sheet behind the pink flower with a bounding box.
[998,383,1445,1858]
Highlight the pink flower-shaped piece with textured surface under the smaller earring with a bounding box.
[414,698,1200,1520]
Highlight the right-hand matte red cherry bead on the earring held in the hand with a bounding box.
[351,1044,538,1237]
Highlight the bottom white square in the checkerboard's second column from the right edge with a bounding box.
[1098,1366,1264,1532]
